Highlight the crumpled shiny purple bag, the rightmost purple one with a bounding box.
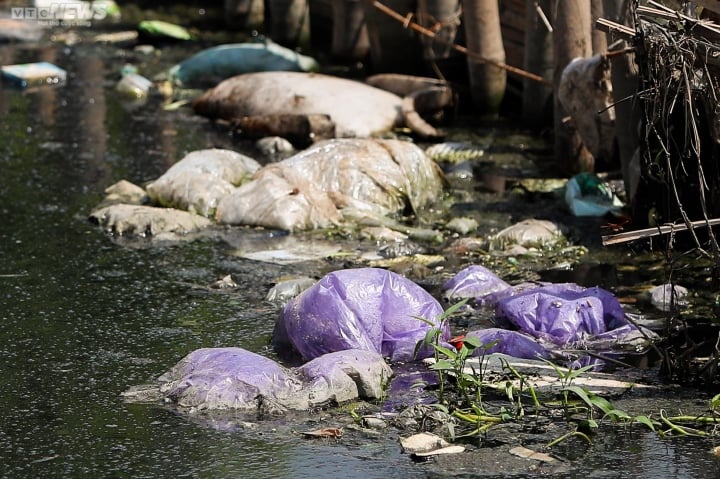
[496,283,629,346]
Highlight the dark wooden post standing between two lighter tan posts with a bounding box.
[522,0,553,129]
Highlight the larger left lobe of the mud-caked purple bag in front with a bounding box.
[158,348,302,410]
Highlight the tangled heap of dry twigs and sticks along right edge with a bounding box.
[597,1,720,260]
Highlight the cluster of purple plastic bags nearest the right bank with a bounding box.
[443,265,653,359]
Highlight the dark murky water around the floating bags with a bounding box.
[0,8,720,478]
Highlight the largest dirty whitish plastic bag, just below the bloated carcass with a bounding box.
[216,139,443,231]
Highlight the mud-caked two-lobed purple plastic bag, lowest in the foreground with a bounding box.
[158,347,393,412]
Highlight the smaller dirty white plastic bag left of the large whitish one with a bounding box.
[146,148,260,216]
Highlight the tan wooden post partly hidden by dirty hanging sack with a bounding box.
[553,1,595,174]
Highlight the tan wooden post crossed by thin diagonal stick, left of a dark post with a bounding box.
[462,0,507,115]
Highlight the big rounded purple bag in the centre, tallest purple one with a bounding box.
[273,268,450,361]
